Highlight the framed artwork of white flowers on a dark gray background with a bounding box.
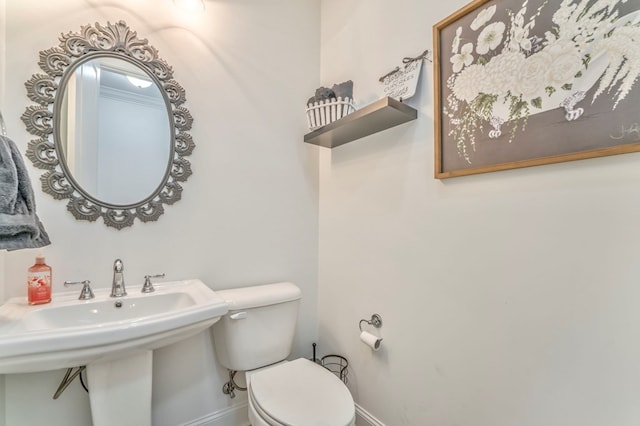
[434,0,640,178]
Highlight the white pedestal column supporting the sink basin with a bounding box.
[87,350,153,426]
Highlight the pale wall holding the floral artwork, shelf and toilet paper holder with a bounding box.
[318,0,640,426]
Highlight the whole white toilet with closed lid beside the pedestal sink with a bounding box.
[213,283,355,426]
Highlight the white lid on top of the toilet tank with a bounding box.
[216,282,302,311]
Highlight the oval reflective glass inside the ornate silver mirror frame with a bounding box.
[55,57,171,206]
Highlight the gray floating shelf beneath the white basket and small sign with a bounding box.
[304,97,418,148]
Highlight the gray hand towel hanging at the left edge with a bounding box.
[0,135,51,250]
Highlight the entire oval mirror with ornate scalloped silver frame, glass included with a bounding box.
[22,21,195,229]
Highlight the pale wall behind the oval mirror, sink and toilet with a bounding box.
[0,0,320,426]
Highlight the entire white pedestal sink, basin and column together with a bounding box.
[0,280,228,426]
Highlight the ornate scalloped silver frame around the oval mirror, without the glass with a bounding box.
[21,21,195,230]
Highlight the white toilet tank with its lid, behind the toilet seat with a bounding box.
[213,282,302,371]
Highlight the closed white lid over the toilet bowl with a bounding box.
[250,358,355,426]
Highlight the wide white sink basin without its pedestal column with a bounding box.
[0,280,228,374]
